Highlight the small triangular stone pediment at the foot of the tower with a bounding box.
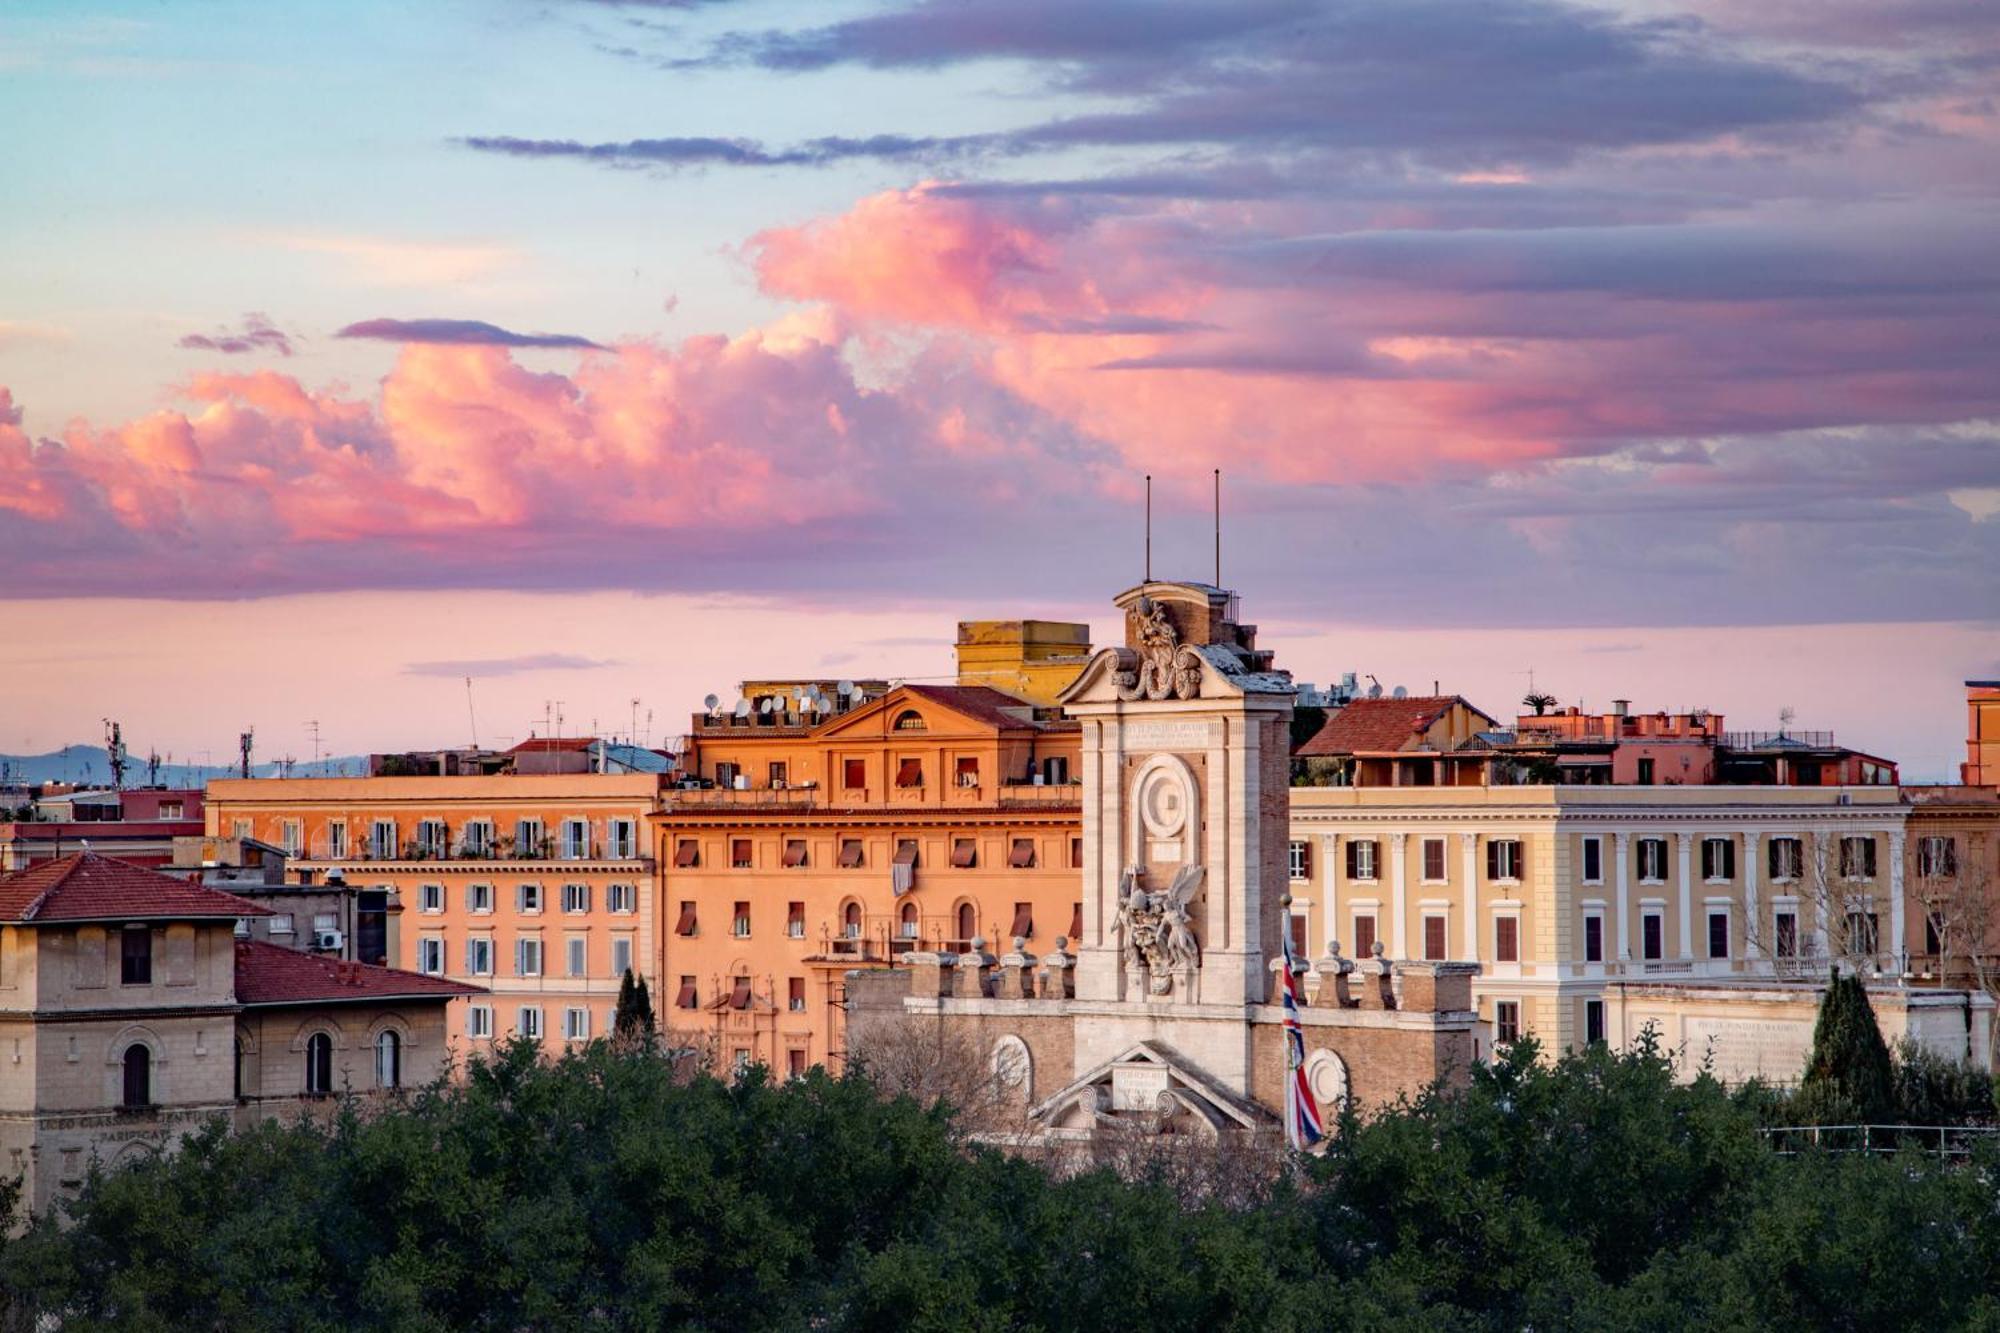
[1028,1041,1274,1137]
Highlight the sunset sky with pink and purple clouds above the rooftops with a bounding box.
[0,0,2000,779]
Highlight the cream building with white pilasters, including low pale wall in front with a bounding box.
[1288,787,1990,1079]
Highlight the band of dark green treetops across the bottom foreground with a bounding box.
[11,1039,2000,1331]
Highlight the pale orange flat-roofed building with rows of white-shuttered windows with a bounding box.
[206,773,666,1049]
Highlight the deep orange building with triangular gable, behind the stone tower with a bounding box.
[652,685,1082,1073]
